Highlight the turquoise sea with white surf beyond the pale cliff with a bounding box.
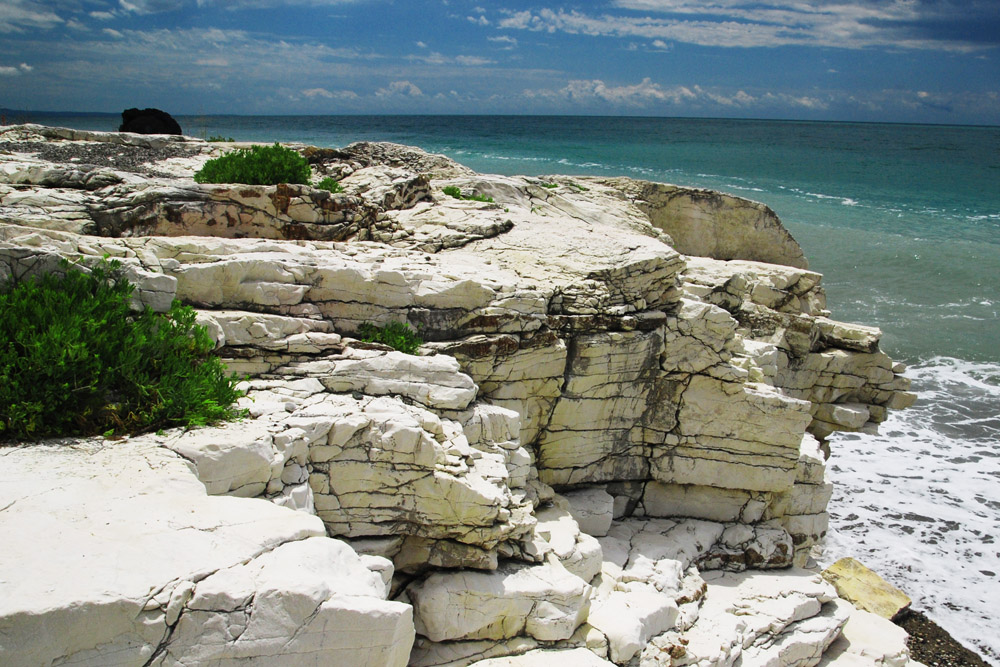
[22,114,1000,665]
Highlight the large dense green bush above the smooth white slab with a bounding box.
[0,261,243,440]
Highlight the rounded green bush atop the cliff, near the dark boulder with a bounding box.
[194,142,310,185]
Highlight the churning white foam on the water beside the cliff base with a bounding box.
[823,357,1000,662]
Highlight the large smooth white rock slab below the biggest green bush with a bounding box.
[0,436,413,665]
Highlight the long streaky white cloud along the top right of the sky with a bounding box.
[499,0,1000,51]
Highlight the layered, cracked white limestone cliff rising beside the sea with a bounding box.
[0,126,913,665]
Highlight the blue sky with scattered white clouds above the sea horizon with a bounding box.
[0,0,1000,125]
